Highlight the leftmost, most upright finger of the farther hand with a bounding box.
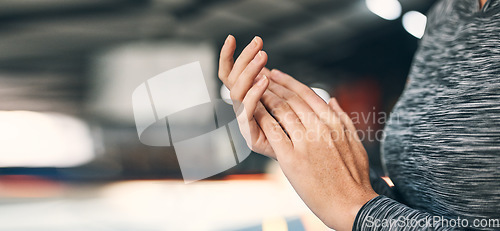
[219,35,236,88]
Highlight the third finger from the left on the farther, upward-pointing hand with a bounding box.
[231,51,267,102]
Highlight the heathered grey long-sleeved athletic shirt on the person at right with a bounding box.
[353,0,500,230]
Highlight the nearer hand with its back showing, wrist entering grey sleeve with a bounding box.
[261,70,377,230]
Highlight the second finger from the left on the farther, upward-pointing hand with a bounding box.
[227,36,263,89]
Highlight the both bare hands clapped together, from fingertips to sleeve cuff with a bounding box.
[219,36,377,230]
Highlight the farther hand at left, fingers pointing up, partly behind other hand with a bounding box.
[219,35,279,159]
